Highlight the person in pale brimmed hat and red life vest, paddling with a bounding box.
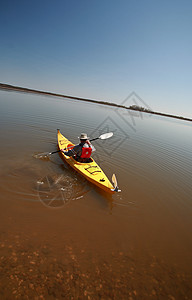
[62,133,95,163]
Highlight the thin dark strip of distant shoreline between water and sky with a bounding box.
[0,83,192,122]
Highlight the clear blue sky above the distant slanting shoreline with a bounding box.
[0,0,192,117]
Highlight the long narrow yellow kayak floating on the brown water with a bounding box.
[57,129,116,193]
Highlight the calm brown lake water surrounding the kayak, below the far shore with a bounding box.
[0,91,192,300]
